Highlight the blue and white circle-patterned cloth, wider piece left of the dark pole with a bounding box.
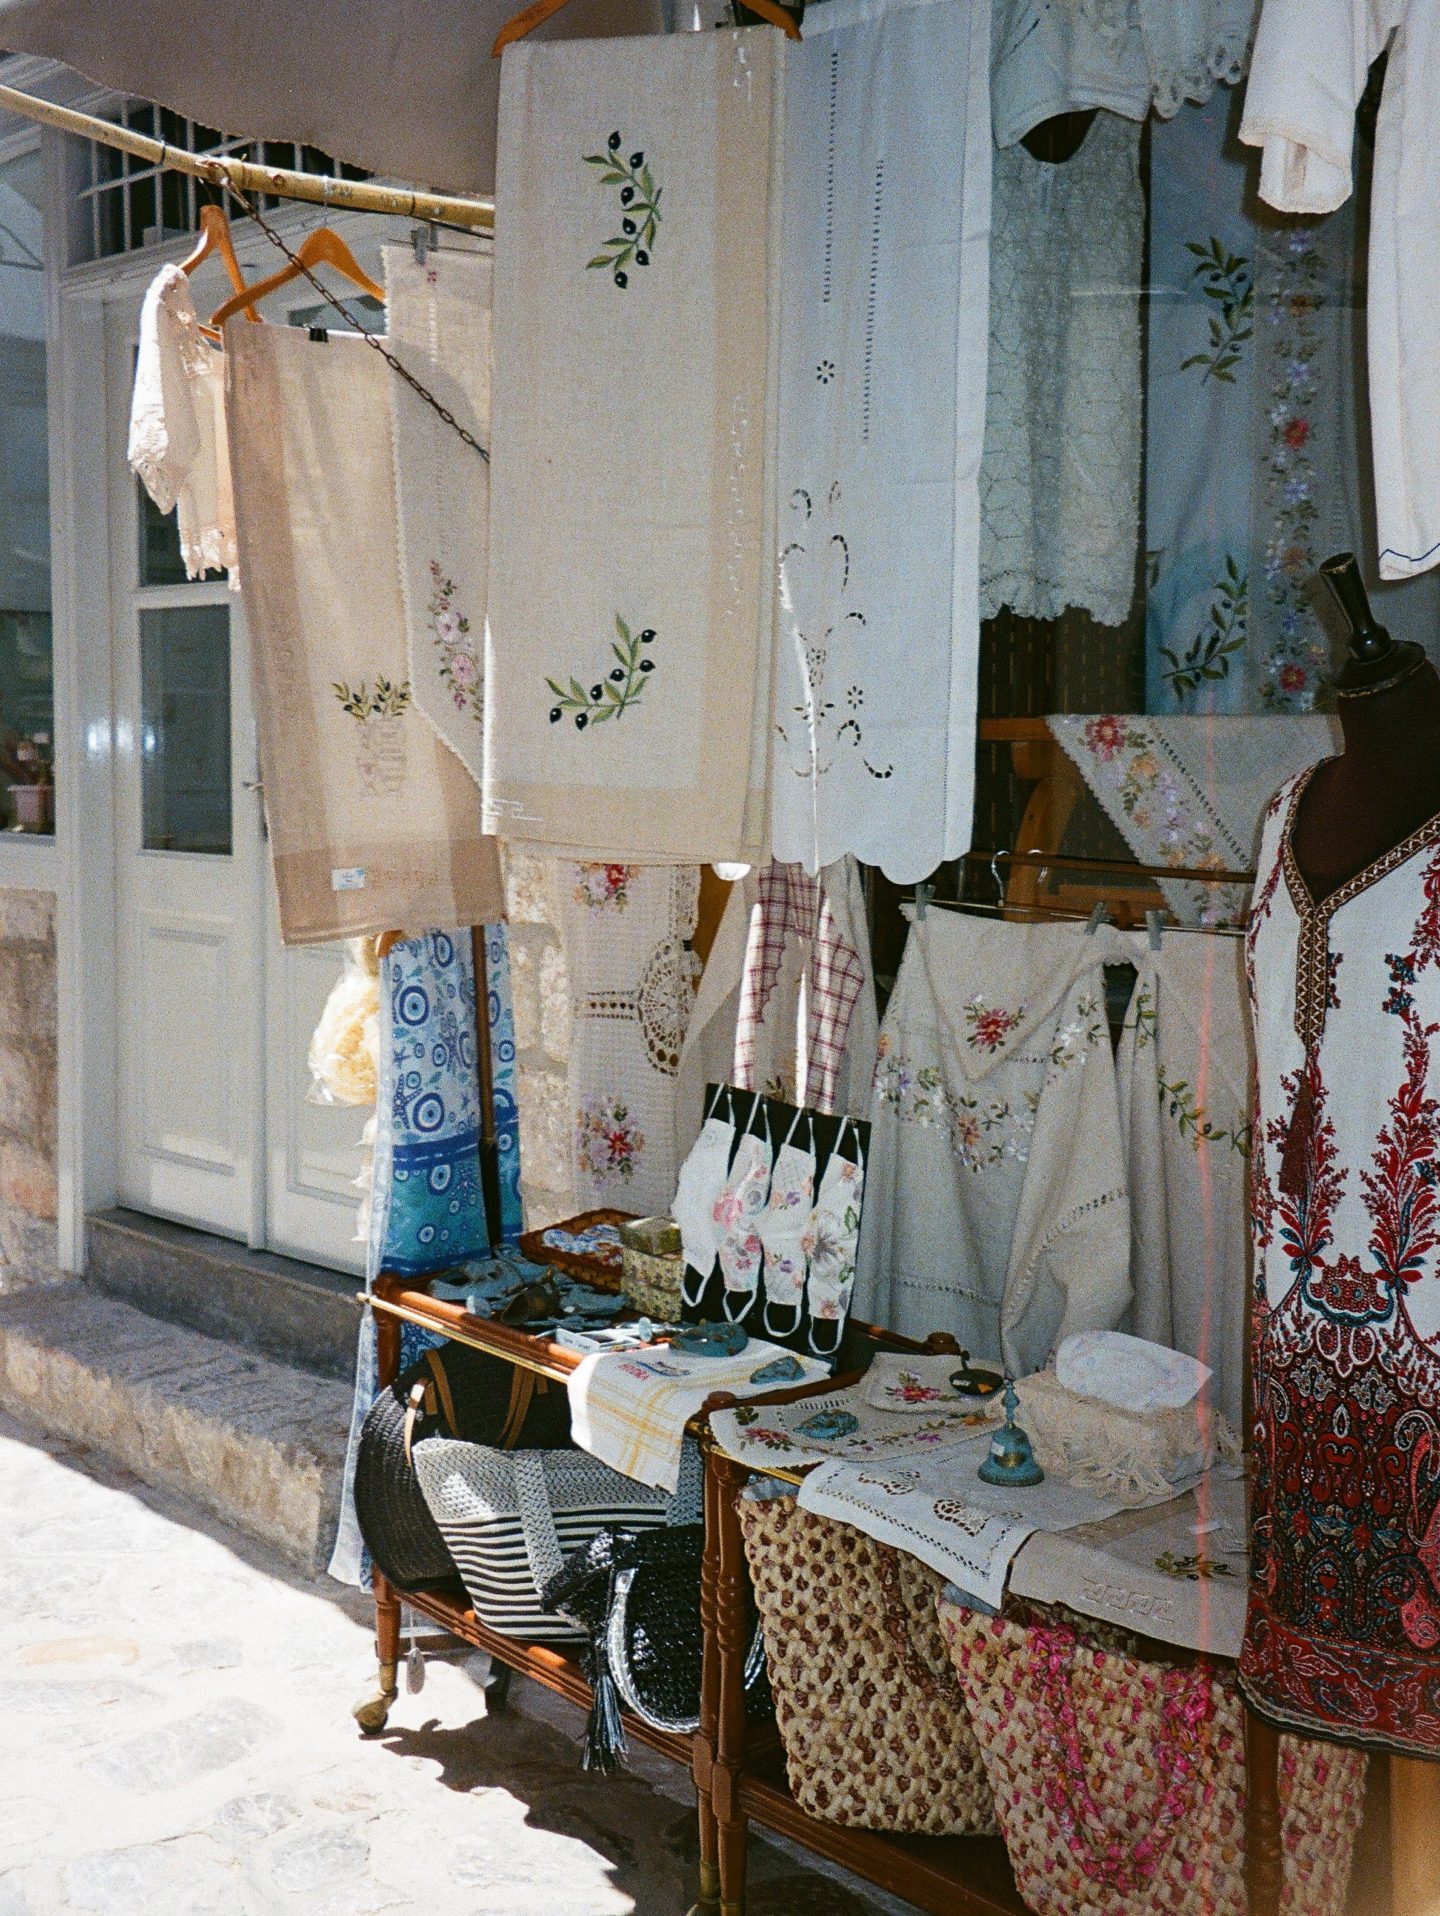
[370,931,490,1278]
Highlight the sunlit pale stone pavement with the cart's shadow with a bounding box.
[0,1416,902,1916]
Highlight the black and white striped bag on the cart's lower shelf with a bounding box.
[414,1437,676,1642]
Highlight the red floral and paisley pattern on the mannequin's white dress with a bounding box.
[1241,816,1440,1755]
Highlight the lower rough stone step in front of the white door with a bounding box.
[0,1280,350,1571]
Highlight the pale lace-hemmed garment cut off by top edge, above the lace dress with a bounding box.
[992,0,1256,146]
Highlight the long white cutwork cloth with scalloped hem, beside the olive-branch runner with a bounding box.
[774,0,990,883]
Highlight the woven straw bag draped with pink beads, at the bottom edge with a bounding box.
[938,1600,1365,1916]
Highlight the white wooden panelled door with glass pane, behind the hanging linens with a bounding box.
[105,284,368,1268]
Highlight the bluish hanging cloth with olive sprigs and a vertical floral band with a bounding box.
[1145,82,1440,713]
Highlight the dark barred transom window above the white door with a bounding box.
[71,100,368,264]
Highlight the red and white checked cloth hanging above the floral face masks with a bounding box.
[733,864,866,1113]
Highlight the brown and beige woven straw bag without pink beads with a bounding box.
[739,1496,996,1836]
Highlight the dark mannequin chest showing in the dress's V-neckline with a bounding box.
[1291,661,1440,902]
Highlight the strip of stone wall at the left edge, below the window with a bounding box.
[0,887,59,1295]
